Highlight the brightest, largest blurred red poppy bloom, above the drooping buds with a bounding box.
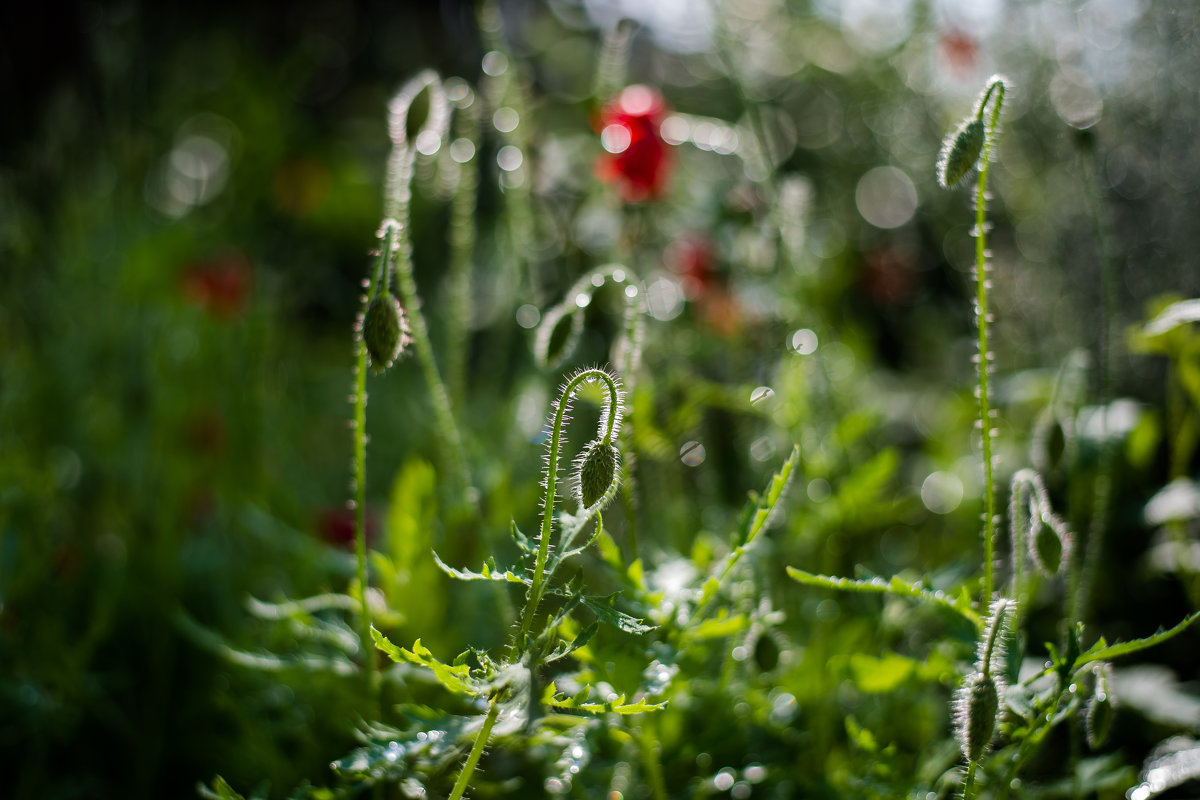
[596,85,671,203]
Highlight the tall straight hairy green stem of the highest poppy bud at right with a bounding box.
[974,78,1004,608]
